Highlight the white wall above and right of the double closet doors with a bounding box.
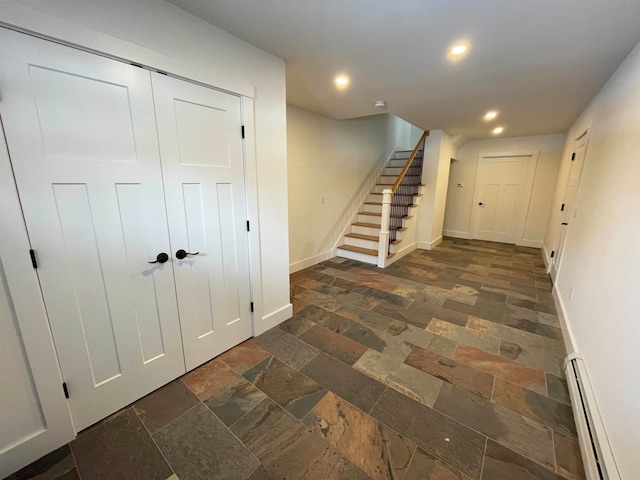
[0,0,291,333]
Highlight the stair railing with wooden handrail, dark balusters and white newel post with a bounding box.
[378,130,429,268]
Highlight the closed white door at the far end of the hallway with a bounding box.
[473,154,537,243]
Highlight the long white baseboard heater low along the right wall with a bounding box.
[564,353,620,480]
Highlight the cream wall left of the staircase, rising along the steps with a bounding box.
[287,106,411,272]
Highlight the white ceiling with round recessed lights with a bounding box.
[169,0,640,139]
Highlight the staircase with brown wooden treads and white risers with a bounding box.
[337,137,428,266]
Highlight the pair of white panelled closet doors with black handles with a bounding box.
[0,28,252,430]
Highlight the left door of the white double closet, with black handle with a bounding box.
[0,29,185,430]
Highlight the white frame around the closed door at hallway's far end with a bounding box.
[469,150,540,247]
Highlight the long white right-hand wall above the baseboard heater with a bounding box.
[545,37,640,479]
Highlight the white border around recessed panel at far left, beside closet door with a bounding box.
[0,126,75,478]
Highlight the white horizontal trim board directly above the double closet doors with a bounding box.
[0,0,255,97]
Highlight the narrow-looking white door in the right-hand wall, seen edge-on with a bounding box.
[549,135,588,281]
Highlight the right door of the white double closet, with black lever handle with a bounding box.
[152,74,252,370]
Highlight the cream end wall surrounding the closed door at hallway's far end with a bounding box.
[444,134,565,247]
